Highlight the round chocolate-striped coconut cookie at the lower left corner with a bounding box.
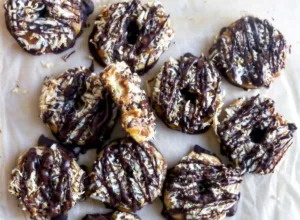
[9,144,85,220]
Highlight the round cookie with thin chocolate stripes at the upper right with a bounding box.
[209,16,288,89]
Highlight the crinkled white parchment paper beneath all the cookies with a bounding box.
[0,0,300,220]
